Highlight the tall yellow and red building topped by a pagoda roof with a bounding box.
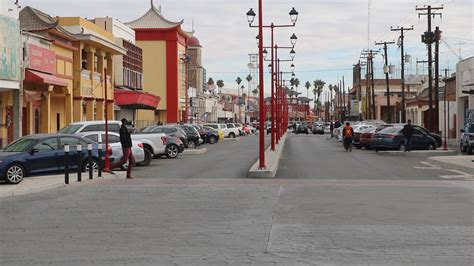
[125,1,189,123]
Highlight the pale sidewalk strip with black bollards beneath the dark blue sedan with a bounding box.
[0,171,125,198]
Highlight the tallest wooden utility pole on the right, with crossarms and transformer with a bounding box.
[415,5,443,132]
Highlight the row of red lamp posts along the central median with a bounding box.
[247,0,298,169]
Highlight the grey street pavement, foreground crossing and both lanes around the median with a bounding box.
[0,134,474,265]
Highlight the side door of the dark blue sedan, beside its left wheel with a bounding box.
[26,137,62,173]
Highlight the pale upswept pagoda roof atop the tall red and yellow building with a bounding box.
[125,0,183,29]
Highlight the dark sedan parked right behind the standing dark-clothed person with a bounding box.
[371,125,437,151]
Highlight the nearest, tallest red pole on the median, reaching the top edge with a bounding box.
[258,0,267,169]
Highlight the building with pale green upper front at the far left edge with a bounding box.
[0,0,22,147]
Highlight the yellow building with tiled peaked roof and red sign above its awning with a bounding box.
[20,7,77,135]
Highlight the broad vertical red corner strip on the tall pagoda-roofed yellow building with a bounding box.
[166,41,179,123]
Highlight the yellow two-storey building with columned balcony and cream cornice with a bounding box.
[58,17,126,122]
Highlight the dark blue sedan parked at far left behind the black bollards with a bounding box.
[0,134,99,184]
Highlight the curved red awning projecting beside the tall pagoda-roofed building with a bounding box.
[114,89,161,110]
